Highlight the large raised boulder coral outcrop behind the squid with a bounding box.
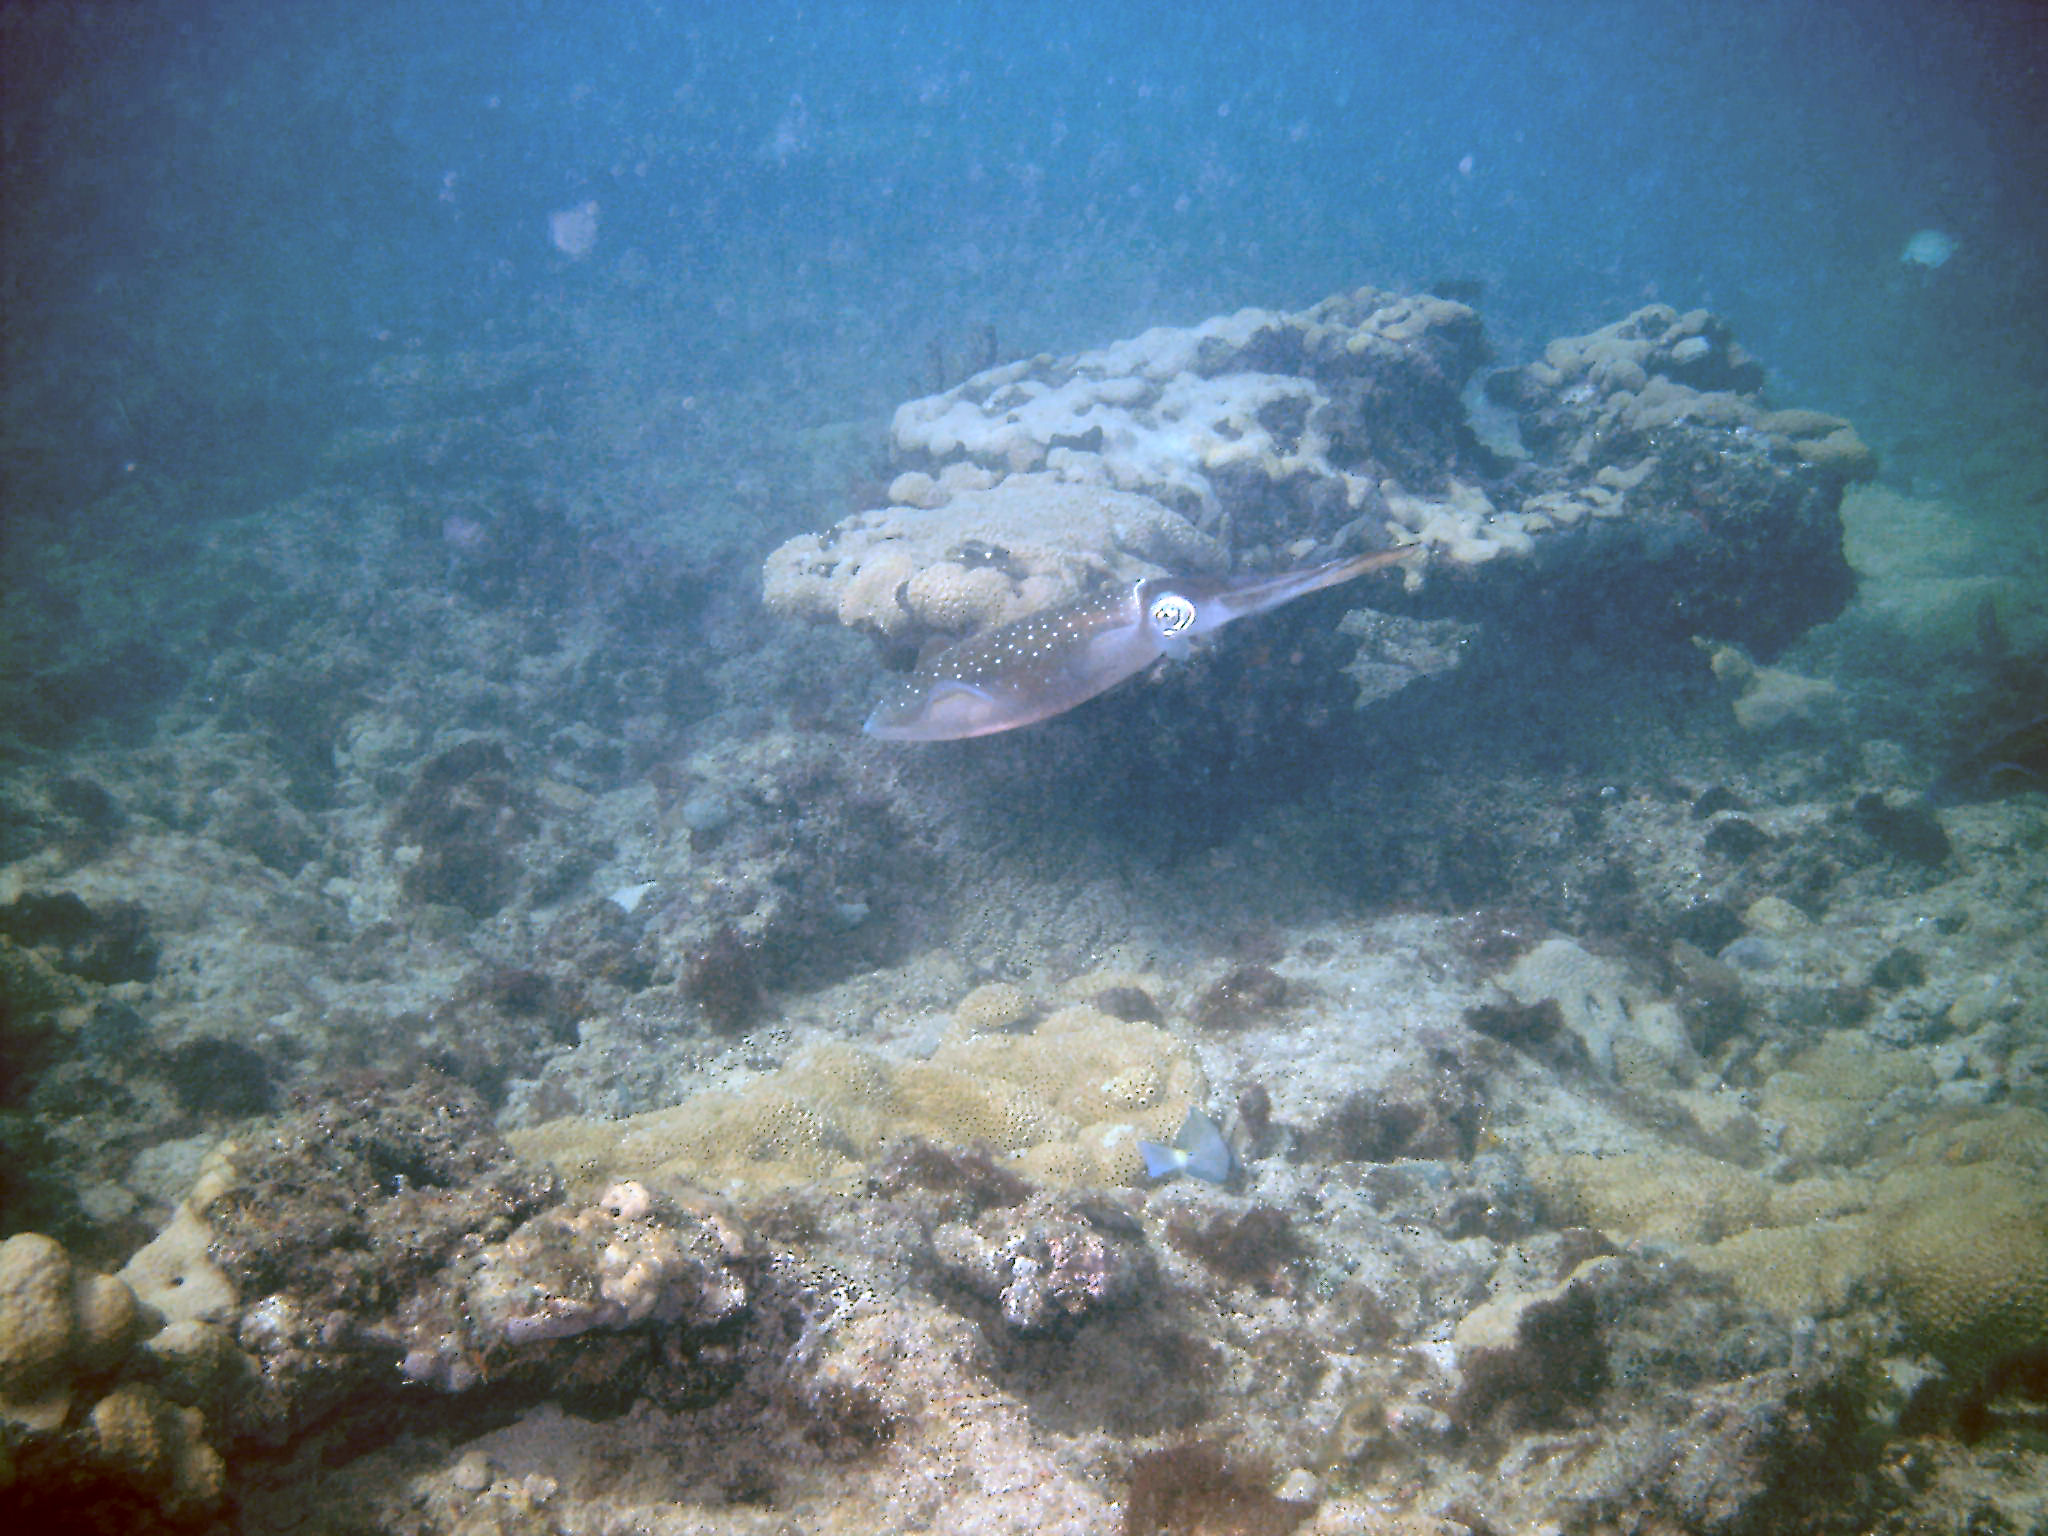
[764,289,1874,696]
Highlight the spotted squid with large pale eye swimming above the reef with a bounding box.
[862,549,1409,741]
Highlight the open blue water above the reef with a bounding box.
[0,0,2048,520]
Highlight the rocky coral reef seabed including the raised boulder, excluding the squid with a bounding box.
[0,256,2048,1536]
